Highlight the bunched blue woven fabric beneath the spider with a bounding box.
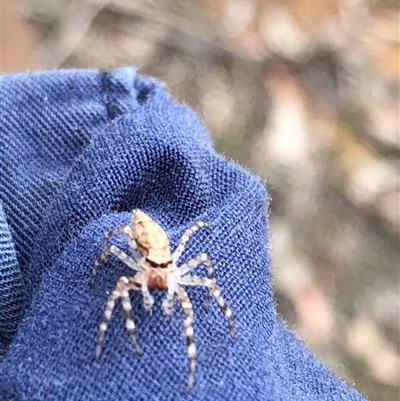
[0,68,363,401]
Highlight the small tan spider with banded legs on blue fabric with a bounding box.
[91,210,235,388]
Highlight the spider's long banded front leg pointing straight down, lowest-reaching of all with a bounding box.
[175,287,196,388]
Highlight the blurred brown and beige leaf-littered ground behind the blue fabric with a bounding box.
[1,0,400,401]
